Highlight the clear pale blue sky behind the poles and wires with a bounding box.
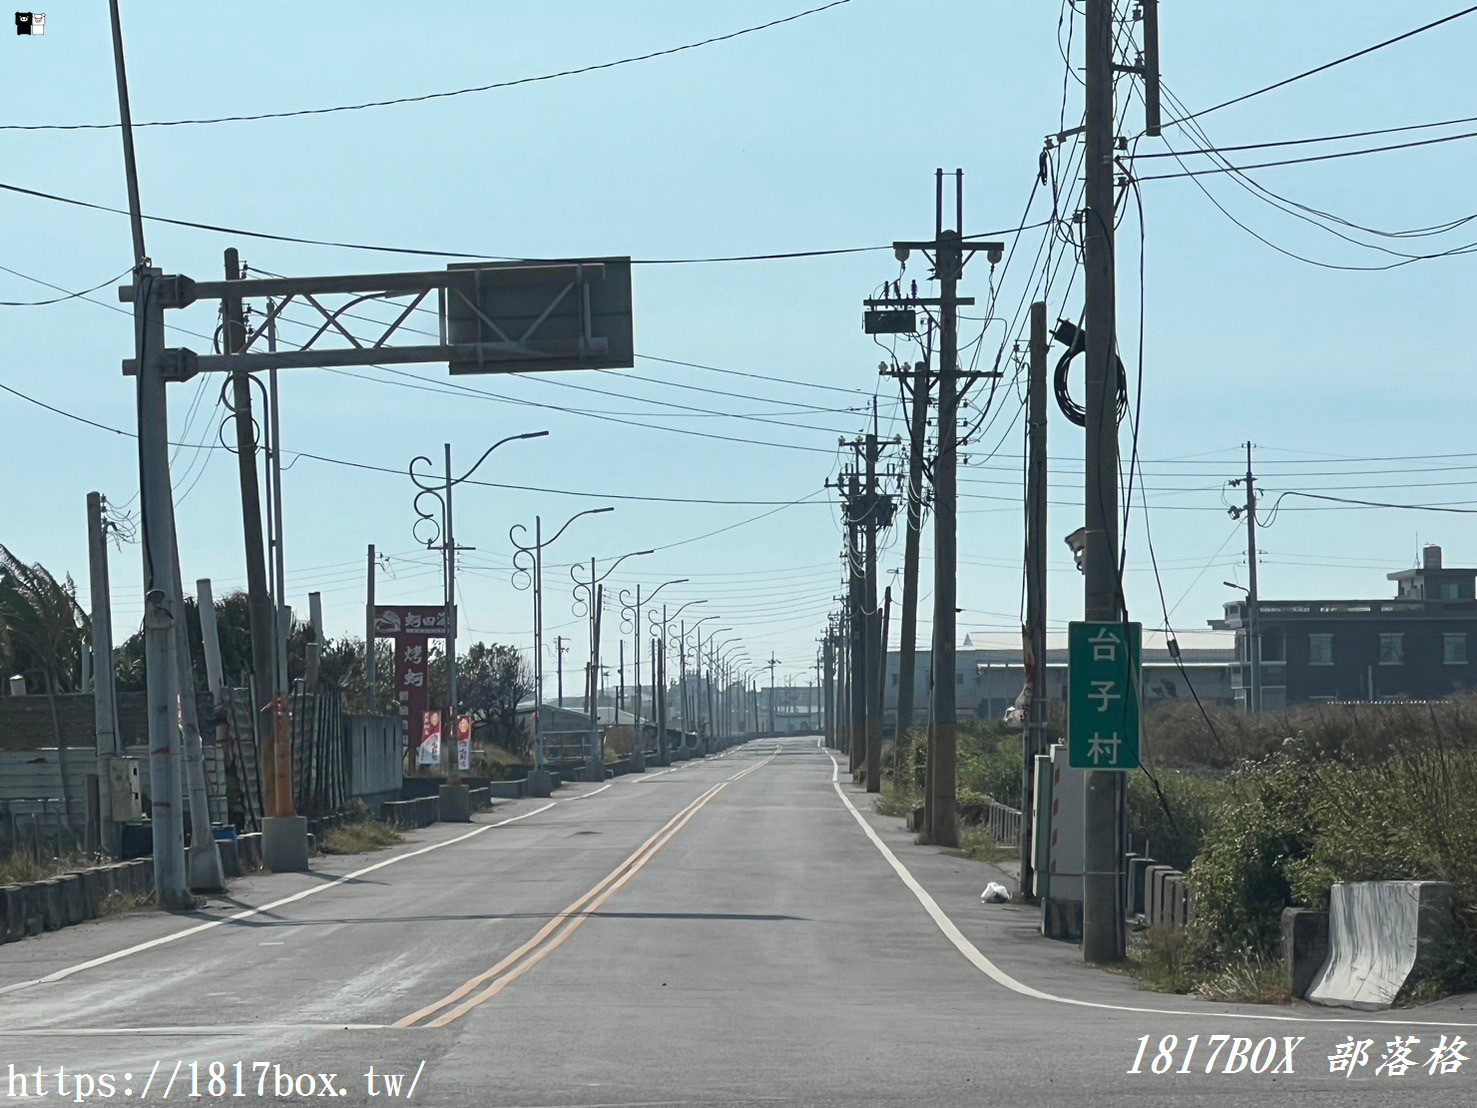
[0,0,1477,694]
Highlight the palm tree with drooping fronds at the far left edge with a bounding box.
[0,545,90,827]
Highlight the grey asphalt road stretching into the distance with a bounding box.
[0,737,1477,1107]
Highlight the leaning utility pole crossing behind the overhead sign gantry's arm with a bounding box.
[222,247,278,815]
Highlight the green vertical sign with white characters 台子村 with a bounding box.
[1066,623,1143,770]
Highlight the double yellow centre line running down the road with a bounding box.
[393,750,778,1027]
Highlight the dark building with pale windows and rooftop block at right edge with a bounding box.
[1210,547,1477,712]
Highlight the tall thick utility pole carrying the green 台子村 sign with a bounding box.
[1083,0,1124,963]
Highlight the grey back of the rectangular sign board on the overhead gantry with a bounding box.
[442,257,635,374]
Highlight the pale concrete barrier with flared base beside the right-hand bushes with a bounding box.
[1307,880,1452,1012]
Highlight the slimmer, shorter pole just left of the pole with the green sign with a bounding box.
[1021,300,1049,895]
